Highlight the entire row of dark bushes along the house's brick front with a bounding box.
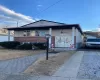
[0,41,47,50]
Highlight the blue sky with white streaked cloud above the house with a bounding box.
[0,0,100,30]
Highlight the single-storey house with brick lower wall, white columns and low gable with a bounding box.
[6,20,83,49]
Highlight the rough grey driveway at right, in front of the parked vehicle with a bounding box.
[77,50,100,80]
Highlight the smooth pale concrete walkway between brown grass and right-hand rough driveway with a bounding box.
[53,51,84,80]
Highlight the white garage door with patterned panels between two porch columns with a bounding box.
[55,36,71,47]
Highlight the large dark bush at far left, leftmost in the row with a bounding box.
[0,41,20,49]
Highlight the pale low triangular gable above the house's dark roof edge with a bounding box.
[22,20,65,27]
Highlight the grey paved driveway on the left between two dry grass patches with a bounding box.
[0,54,45,74]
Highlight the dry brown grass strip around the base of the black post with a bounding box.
[24,51,75,76]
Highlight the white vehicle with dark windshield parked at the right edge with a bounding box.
[86,38,100,48]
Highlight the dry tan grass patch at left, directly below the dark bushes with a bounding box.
[0,49,45,60]
